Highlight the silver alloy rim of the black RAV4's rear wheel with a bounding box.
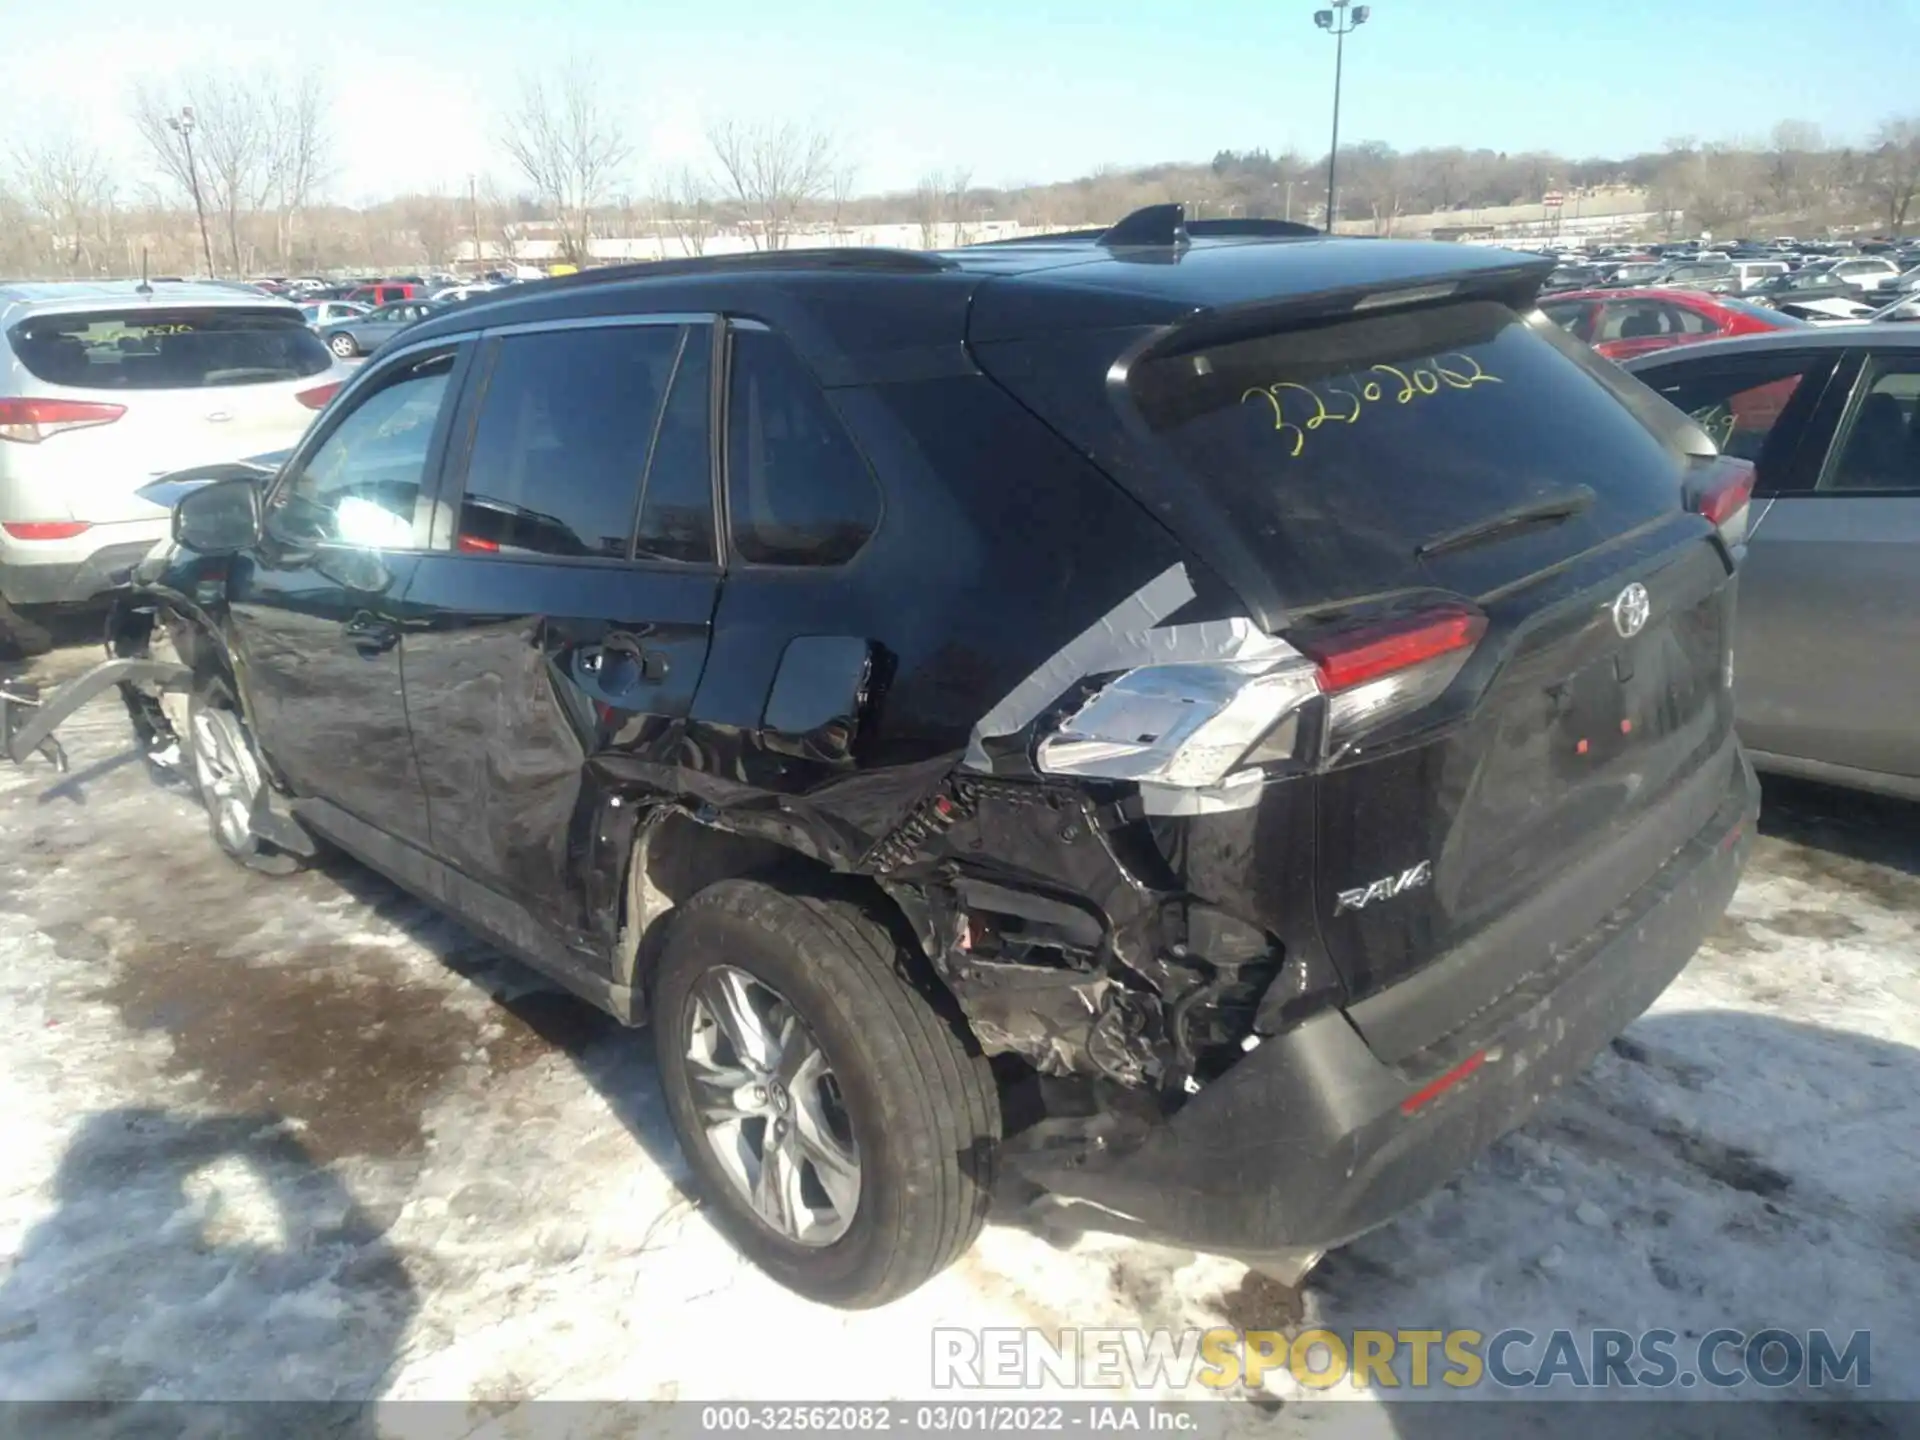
[685,966,860,1246]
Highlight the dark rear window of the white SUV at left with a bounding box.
[8,309,332,390]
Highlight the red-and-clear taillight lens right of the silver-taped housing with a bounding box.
[1294,605,1486,755]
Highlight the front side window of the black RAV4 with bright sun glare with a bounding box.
[267,351,453,549]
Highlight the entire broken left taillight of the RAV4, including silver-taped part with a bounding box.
[1035,605,1486,789]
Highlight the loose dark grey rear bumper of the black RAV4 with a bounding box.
[1008,756,1759,1256]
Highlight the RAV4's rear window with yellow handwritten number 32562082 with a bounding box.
[1133,301,1680,603]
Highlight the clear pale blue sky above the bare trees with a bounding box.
[0,0,1920,200]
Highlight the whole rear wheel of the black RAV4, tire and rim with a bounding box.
[655,879,1000,1309]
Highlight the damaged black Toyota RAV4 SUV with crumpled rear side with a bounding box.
[8,207,1757,1306]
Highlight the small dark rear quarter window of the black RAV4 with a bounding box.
[728,330,879,564]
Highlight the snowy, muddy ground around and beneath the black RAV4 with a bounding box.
[0,637,1920,1436]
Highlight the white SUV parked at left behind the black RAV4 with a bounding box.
[0,280,349,605]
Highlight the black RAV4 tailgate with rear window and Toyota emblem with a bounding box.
[1133,301,1734,995]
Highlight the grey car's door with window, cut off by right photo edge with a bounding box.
[1740,349,1920,780]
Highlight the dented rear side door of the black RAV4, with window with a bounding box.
[407,317,720,947]
